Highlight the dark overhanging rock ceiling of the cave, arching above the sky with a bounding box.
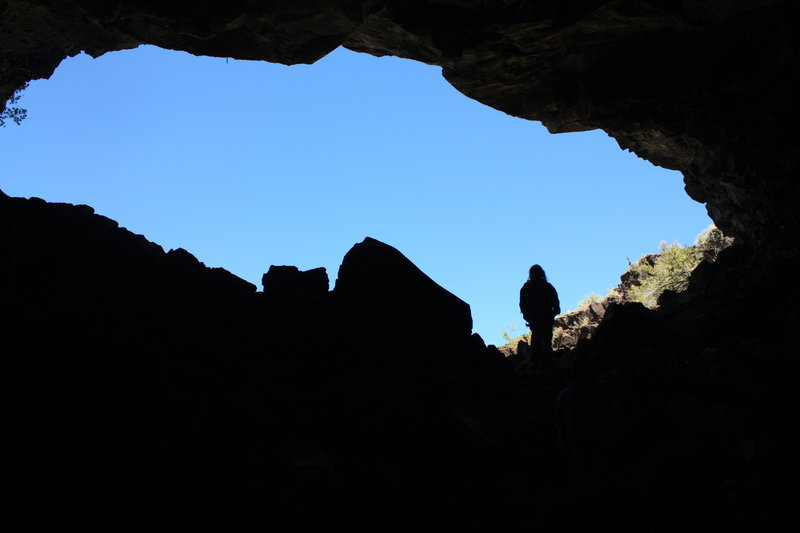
[0,0,800,248]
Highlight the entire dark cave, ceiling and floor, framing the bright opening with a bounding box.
[0,0,800,531]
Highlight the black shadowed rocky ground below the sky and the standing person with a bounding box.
[0,189,800,531]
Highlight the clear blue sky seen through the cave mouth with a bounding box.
[0,46,711,345]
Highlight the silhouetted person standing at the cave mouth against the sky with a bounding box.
[519,265,561,365]
